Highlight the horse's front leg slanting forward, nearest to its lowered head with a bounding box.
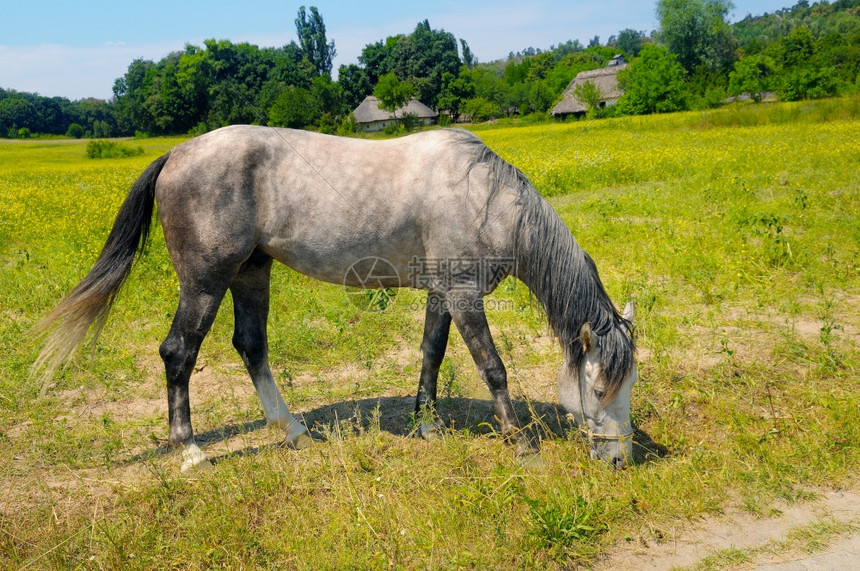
[451,297,538,455]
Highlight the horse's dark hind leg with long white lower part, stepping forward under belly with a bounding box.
[230,250,311,448]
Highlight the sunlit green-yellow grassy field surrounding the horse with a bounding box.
[0,99,860,569]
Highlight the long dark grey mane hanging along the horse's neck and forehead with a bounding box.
[452,127,635,402]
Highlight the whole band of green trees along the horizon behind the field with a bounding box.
[0,0,860,137]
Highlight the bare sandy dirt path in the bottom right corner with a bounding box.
[595,490,860,570]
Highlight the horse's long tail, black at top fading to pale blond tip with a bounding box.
[31,153,170,386]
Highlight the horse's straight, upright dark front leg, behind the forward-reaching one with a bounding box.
[415,292,451,438]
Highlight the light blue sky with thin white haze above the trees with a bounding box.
[0,0,794,99]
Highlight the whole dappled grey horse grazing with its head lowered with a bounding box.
[34,126,636,471]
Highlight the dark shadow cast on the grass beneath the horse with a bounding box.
[128,396,669,470]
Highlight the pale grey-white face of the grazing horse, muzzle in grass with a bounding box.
[558,303,638,468]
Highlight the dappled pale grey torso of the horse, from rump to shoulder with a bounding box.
[157,126,516,283]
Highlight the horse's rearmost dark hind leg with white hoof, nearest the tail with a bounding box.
[159,280,227,472]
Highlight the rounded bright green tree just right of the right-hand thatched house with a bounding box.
[618,45,687,115]
